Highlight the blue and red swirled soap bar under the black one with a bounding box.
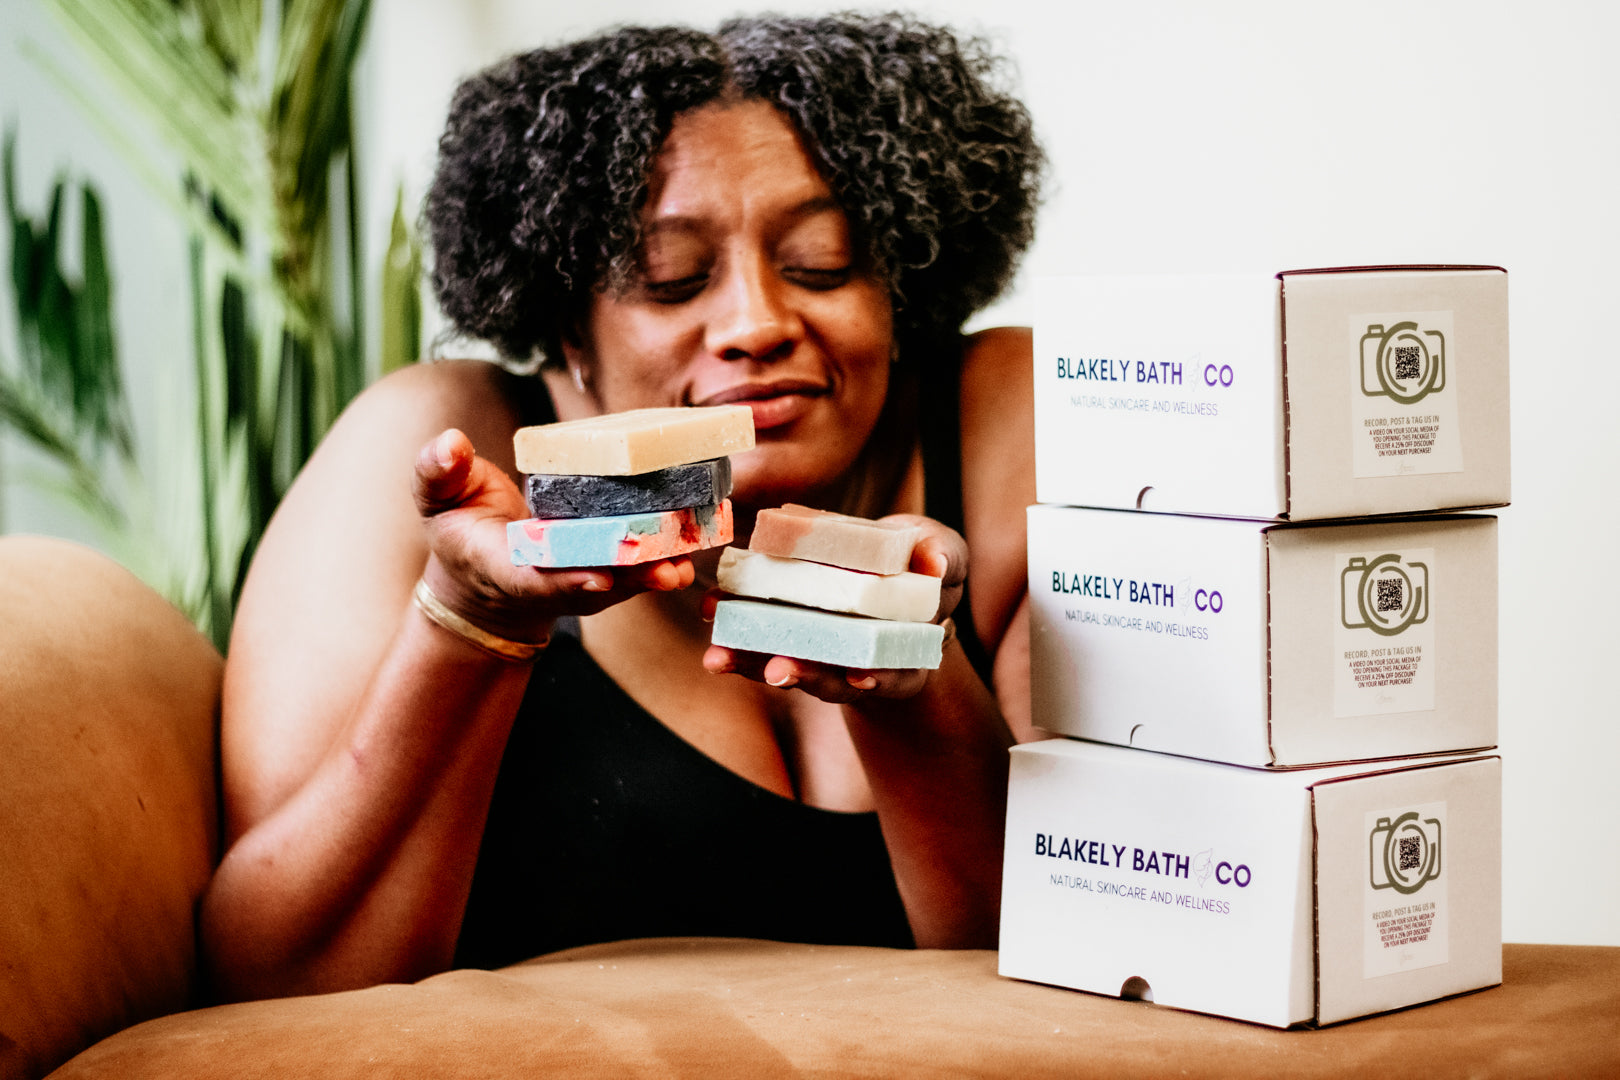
[507,499,732,568]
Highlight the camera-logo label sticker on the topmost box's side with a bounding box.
[1349,311,1463,478]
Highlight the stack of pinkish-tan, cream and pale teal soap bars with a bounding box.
[711,504,944,669]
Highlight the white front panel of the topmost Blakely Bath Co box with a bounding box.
[1034,274,1283,518]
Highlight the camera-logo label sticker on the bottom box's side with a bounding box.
[1362,803,1452,978]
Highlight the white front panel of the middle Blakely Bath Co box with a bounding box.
[1029,505,1272,764]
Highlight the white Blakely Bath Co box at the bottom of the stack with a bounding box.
[1000,740,1502,1027]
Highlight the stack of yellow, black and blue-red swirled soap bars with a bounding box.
[507,405,753,567]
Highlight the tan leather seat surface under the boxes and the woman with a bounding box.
[47,939,1620,1080]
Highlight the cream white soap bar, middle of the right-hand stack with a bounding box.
[719,547,940,622]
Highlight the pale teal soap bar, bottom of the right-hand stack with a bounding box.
[710,601,944,669]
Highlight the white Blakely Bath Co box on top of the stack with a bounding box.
[1035,267,1508,521]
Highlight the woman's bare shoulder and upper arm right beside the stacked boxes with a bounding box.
[961,327,1035,654]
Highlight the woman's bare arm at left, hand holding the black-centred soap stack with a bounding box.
[201,364,690,997]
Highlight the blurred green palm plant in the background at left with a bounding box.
[14,0,387,646]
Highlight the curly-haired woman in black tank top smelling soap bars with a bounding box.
[203,16,1040,996]
